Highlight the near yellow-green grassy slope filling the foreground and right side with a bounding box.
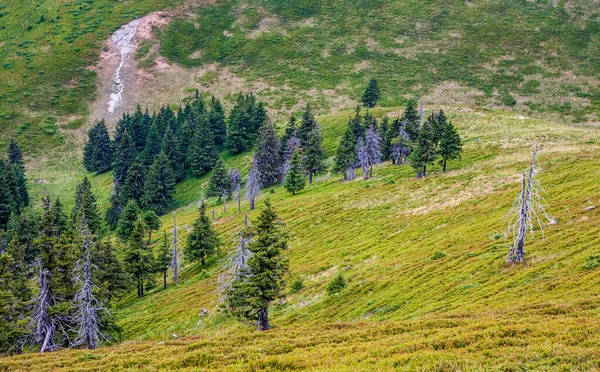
[0,108,600,370]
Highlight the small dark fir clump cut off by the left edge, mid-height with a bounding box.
[0,139,29,228]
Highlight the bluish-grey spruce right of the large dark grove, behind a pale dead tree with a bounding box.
[256,121,282,187]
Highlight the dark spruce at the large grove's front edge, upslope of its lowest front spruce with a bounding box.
[187,117,219,176]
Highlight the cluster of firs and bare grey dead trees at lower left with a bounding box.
[0,179,129,353]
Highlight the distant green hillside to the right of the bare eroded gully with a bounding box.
[160,0,600,121]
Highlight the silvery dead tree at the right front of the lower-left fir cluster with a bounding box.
[73,217,108,349]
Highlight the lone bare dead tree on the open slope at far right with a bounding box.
[505,146,553,263]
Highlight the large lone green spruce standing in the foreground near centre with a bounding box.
[226,200,288,331]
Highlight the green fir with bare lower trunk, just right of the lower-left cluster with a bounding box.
[123,220,153,297]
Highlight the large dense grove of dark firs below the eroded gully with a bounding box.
[84,92,267,228]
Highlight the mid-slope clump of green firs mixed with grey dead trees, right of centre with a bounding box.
[333,100,462,180]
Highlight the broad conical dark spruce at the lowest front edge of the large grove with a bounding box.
[143,152,175,215]
